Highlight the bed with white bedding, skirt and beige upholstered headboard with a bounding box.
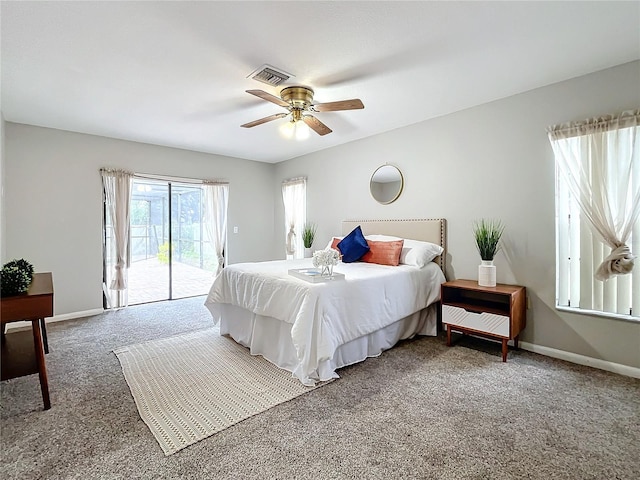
[205,219,446,385]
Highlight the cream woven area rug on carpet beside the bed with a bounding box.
[114,328,326,455]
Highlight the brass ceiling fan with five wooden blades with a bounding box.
[240,86,364,135]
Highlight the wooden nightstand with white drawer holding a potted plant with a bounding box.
[440,280,527,362]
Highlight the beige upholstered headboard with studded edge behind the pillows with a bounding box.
[342,218,447,273]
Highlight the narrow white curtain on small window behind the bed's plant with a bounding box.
[282,177,307,258]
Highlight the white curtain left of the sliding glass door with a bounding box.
[100,169,133,307]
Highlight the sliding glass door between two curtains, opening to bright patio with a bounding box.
[129,178,215,305]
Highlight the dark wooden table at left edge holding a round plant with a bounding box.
[0,272,53,410]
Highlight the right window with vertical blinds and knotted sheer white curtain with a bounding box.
[548,110,640,321]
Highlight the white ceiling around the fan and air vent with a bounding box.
[1,1,640,162]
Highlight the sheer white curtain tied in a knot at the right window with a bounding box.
[548,110,640,280]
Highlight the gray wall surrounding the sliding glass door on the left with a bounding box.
[3,122,275,315]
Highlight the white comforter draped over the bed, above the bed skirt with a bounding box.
[205,259,445,384]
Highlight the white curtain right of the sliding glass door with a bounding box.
[202,181,229,275]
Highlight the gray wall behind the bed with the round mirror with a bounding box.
[274,62,640,367]
